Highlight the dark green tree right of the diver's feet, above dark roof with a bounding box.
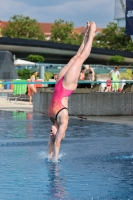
[93,22,133,51]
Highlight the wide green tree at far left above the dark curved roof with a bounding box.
[2,15,45,40]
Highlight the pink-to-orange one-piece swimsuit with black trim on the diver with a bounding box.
[48,77,73,123]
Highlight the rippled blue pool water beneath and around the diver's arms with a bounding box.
[0,111,133,200]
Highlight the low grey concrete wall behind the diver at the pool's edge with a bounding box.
[33,88,133,116]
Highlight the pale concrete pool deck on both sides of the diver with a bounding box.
[0,97,133,126]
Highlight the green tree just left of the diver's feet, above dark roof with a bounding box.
[51,19,83,45]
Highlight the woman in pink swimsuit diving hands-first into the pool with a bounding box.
[48,22,96,161]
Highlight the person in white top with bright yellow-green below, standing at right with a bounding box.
[109,66,120,92]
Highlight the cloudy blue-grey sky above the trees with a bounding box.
[0,0,116,28]
